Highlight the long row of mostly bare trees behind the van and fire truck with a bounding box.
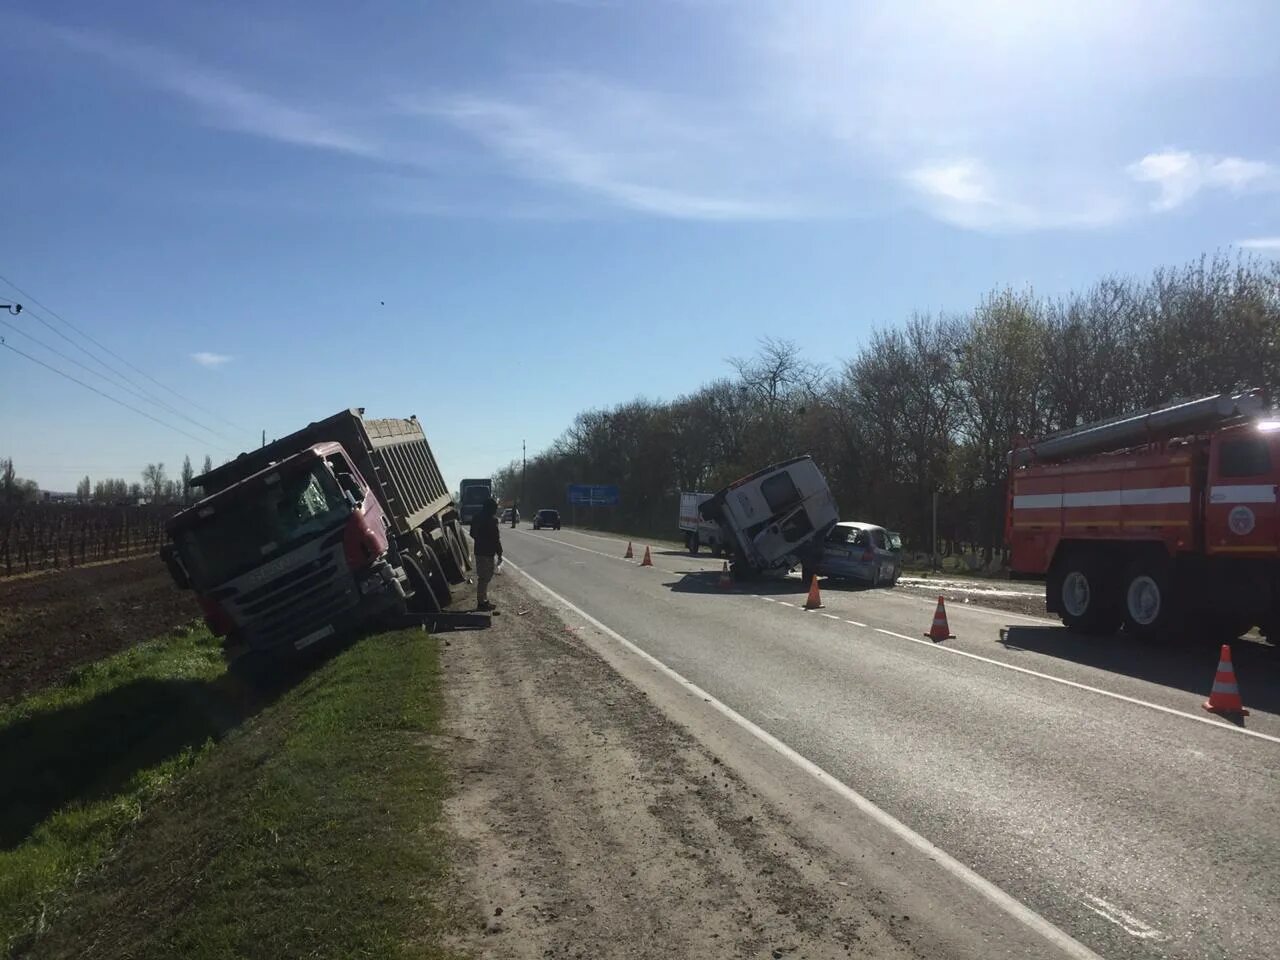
[495,253,1280,563]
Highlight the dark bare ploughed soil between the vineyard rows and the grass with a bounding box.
[0,557,200,703]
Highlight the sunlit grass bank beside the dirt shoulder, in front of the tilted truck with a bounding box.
[0,631,452,959]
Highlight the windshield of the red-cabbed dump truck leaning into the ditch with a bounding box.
[177,463,351,589]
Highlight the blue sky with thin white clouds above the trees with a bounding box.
[0,0,1280,489]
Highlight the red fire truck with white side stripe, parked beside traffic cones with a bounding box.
[1005,390,1280,641]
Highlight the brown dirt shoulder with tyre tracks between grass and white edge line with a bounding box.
[440,576,915,960]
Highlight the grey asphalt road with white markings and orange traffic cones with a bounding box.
[503,527,1280,960]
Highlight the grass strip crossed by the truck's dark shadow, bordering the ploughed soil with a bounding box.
[0,630,225,952]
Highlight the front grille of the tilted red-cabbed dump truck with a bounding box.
[228,550,358,648]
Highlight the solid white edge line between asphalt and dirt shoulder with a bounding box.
[511,563,1102,960]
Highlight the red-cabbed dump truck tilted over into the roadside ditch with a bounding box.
[163,408,471,654]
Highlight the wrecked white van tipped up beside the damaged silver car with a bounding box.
[698,457,840,580]
